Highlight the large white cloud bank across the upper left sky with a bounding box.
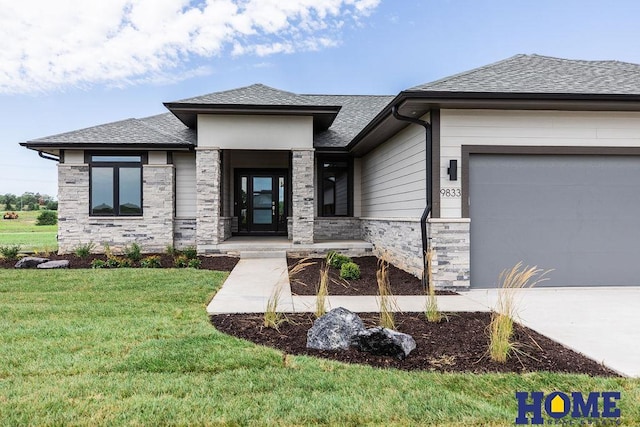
[0,0,380,93]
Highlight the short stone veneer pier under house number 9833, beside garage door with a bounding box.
[429,218,471,288]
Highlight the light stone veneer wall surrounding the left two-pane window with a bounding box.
[58,164,173,253]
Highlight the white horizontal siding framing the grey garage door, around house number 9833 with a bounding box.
[440,110,640,218]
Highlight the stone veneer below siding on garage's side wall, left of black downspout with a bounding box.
[360,218,423,277]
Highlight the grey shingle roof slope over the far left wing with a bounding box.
[27,113,195,146]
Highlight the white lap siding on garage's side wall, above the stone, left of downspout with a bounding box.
[361,126,426,218]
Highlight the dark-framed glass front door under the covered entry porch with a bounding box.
[235,171,287,234]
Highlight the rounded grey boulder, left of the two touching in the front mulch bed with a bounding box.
[307,307,366,350]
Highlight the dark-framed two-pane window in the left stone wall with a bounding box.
[89,154,143,216]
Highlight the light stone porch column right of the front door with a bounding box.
[291,149,315,245]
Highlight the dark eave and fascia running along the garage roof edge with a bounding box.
[347,91,640,156]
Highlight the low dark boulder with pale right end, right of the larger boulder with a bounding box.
[351,327,416,360]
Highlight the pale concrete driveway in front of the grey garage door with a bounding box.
[463,286,640,377]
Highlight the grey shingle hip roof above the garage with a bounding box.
[408,55,640,95]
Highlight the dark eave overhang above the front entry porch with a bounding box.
[164,102,342,132]
